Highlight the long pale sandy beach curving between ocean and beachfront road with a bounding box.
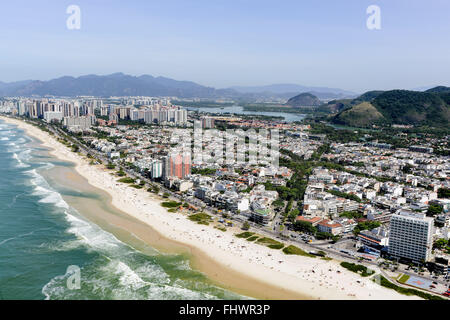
[0,117,419,300]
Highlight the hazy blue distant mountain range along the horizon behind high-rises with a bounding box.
[0,73,354,100]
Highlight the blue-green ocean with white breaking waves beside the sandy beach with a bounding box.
[0,120,245,300]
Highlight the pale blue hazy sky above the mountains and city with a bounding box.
[0,0,450,92]
